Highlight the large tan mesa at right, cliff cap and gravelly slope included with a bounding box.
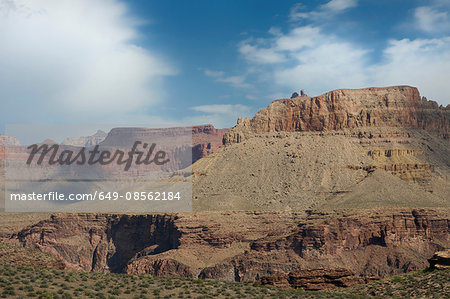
[193,86,450,210]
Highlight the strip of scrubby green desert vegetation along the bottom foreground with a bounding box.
[0,264,450,299]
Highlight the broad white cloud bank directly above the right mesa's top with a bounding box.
[234,26,450,105]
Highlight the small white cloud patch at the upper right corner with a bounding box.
[414,6,450,33]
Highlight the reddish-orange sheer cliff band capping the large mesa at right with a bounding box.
[224,86,450,144]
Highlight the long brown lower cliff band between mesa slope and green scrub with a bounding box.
[11,209,450,284]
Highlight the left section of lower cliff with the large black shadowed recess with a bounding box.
[13,214,180,272]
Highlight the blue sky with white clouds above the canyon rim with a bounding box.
[0,0,450,128]
